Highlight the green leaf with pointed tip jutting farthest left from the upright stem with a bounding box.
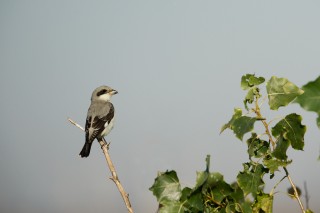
[220,108,257,140]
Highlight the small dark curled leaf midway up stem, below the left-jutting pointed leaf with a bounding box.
[247,133,269,158]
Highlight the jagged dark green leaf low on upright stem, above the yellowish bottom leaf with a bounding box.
[237,163,268,197]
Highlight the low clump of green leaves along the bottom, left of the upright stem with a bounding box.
[150,157,255,213]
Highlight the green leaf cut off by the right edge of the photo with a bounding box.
[295,76,320,128]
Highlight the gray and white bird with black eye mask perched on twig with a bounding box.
[79,86,118,157]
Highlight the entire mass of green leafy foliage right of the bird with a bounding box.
[150,74,320,213]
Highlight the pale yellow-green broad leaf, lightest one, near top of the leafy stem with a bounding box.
[267,76,303,110]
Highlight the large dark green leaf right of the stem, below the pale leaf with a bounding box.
[271,113,307,150]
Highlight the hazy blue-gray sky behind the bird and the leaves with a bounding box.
[0,0,320,213]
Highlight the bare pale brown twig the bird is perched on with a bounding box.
[68,118,133,213]
